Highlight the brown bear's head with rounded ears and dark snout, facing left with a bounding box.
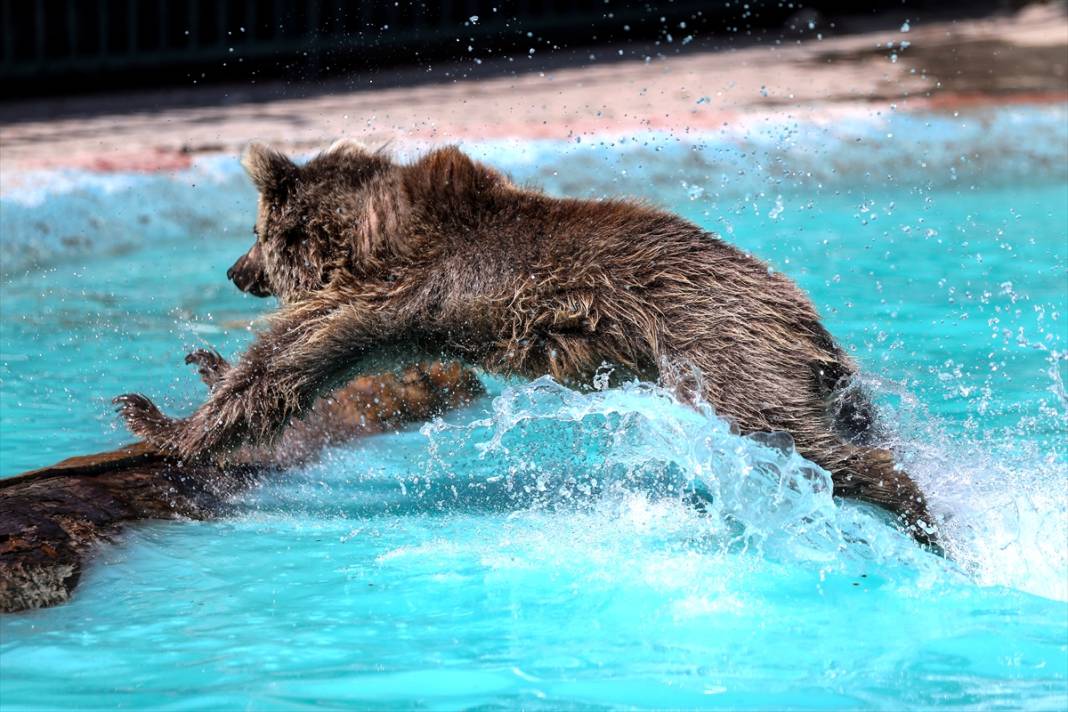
[226,141,392,303]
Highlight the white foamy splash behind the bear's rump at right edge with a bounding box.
[859,371,1068,601]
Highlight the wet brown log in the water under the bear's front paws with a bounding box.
[0,364,482,613]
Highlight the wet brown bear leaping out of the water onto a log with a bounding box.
[115,142,932,540]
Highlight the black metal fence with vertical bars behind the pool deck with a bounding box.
[0,0,982,95]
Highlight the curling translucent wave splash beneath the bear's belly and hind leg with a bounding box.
[407,378,962,584]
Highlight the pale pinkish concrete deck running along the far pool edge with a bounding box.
[0,3,1068,179]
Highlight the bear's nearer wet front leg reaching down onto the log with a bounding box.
[115,301,403,459]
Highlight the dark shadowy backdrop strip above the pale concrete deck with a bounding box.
[0,0,1015,99]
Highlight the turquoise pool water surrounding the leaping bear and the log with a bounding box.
[0,106,1068,710]
